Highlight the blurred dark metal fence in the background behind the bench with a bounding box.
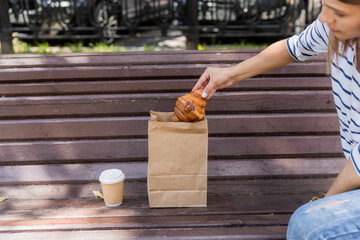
[0,0,321,53]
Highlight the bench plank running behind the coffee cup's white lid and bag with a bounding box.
[0,158,346,185]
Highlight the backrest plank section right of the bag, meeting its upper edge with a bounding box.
[206,113,339,136]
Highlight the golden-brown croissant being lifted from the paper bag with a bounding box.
[171,89,207,122]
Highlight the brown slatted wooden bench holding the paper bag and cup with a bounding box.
[0,50,345,240]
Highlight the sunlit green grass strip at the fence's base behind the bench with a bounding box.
[7,38,268,54]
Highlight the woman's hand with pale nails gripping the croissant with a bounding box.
[192,67,233,99]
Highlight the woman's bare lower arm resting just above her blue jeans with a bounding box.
[325,159,360,197]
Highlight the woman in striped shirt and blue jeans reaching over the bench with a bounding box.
[193,0,360,240]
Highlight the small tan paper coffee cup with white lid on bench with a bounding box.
[99,169,125,207]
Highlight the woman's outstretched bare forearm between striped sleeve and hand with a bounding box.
[229,40,295,83]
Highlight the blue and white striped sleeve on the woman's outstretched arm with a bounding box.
[286,19,329,62]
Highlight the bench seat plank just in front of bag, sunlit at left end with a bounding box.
[0,214,290,232]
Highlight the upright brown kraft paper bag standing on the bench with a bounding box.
[148,111,208,208]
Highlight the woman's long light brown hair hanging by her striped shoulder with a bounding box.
[327,0,360,71]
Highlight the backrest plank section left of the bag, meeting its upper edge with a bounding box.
[0,117,150,140]
